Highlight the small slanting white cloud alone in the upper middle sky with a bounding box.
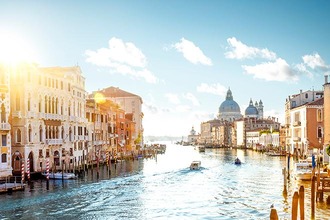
[173,38,212,66]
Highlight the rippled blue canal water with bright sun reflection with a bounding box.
[0,143,330,220]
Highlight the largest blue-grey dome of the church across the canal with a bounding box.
[218,88,242,122]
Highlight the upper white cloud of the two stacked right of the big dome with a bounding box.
[225,37,276,60]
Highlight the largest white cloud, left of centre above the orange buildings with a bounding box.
[85,37,158,83]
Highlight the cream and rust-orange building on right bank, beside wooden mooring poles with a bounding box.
[285,90,324,157]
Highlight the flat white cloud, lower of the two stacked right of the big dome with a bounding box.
[242,58,298,82]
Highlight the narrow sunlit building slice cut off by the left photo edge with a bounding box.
[0,64,12,177]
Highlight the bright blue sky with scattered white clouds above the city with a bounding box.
[0,0,330,136]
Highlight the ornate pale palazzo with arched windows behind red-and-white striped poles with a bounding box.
[10,64,88,173]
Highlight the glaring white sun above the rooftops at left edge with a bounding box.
[0,32,34,64]
